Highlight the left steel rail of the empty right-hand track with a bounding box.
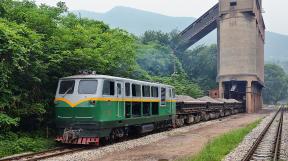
[242,107,283,161]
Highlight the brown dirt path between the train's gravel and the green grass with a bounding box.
[90,110,268,161]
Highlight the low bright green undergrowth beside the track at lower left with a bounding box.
[0,132,56,158]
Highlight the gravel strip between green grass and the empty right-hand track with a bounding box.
[223,109,275,161]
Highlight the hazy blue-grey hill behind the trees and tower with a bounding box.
[72,7,288,62]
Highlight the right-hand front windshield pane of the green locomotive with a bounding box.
[78,80,98,94]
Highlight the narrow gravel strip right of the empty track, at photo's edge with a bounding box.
[279,111,288,160]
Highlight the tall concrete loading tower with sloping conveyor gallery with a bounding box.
[176,0,265,113]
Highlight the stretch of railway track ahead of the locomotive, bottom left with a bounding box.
[0,147,91,161]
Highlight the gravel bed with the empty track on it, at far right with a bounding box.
[223,109,288,161]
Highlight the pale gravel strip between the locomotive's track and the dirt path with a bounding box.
[41,115,248,161]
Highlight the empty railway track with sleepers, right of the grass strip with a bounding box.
[242,106,284,161]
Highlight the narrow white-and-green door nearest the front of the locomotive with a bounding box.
[116,81,124,118]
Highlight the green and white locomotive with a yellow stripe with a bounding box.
[55,74,176,145]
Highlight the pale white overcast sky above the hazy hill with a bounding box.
[35,0,288,35]
